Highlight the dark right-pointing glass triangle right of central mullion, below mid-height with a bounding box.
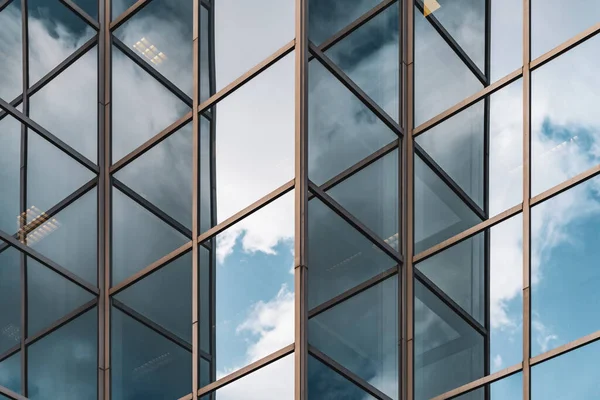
[308,198,396,309]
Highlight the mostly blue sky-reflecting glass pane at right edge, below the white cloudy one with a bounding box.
[531,178,600,355]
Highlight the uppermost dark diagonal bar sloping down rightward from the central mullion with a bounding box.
[308,42,404,137]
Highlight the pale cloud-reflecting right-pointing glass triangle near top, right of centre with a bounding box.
[414,8,483,126]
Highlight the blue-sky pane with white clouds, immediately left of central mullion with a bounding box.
[200,192,294,379]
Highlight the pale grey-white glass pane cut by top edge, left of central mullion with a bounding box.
[208,0,296,90]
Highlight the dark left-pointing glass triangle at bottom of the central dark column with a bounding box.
[308,276,399,399]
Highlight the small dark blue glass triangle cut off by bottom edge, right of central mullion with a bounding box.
[308,355,375,400]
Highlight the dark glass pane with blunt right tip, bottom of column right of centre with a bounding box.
[414,281,485,400]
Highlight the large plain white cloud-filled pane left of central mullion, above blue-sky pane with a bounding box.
[200,54,296,233]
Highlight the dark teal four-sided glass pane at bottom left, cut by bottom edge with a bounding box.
[27,309,98,400]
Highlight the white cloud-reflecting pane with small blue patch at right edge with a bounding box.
[531,36,600,195]
